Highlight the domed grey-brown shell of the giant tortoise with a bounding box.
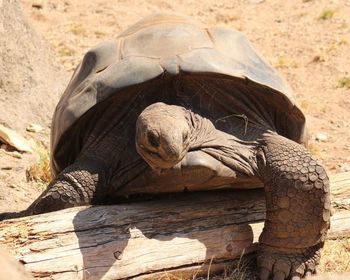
[51,14,306,175]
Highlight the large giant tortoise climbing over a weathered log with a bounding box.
[10,14,330,280]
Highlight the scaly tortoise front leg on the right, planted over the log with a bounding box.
[257,134,330,280]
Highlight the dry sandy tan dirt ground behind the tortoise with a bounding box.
[0,0,350,276]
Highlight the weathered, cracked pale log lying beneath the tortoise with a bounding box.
[0,173,350,279]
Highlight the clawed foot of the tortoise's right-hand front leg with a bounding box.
[257,245,322,280]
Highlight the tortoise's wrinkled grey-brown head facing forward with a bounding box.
[136,102,191,170]
